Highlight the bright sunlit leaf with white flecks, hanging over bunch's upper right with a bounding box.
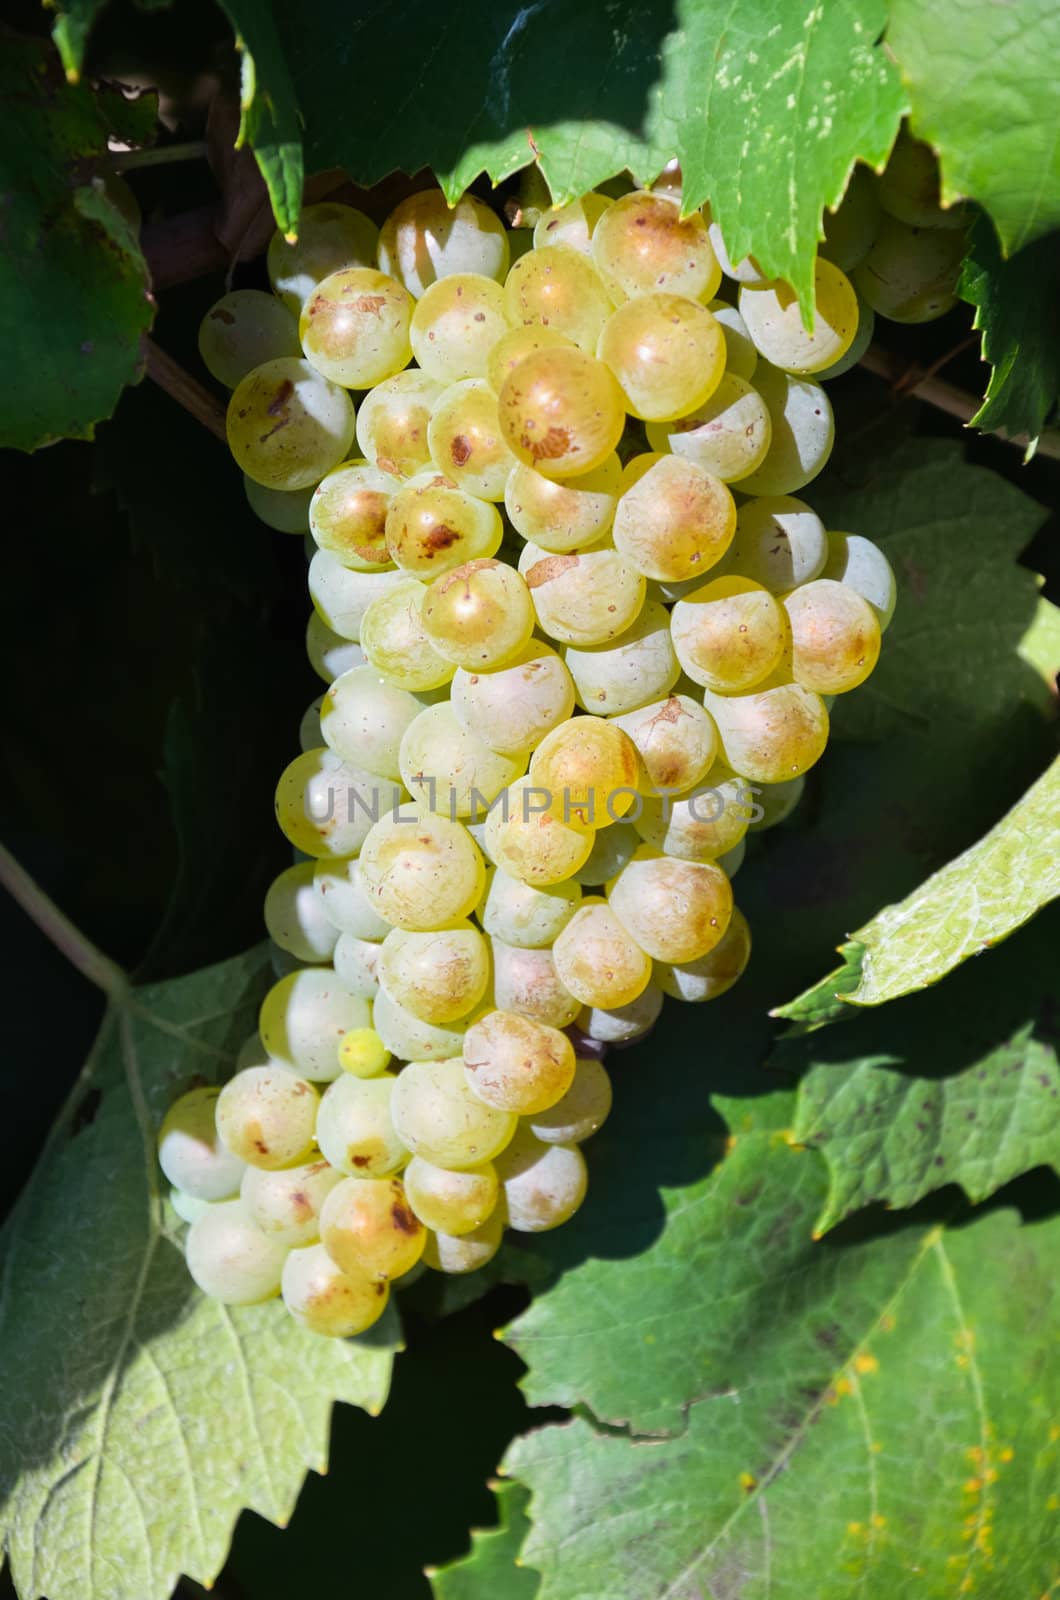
[668,0,905,314]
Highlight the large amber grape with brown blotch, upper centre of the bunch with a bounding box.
[496,347,627,478]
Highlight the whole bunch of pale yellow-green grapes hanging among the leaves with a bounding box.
[160,139,961,1336]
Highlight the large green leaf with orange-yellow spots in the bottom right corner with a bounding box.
[506,1131,1060,1600]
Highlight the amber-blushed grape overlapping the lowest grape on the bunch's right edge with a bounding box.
[608,845,732,976]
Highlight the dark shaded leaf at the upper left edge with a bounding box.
[0,35,154,450]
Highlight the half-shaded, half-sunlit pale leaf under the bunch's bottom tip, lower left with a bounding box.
[0,950,397,1600]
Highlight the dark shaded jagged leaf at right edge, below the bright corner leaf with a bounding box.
[958,216,1060,453]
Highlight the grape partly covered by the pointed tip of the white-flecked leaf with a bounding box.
[740,256,858,373]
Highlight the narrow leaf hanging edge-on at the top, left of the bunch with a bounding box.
[221,0,305,234]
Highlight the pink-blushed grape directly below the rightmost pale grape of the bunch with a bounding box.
[783,578,879,694]
